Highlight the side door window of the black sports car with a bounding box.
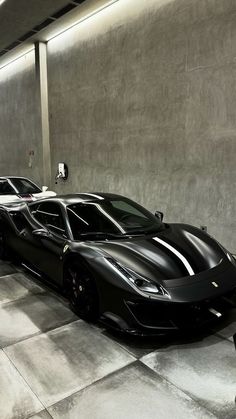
[32,202,66,236]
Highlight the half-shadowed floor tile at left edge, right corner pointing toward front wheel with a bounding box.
[0,293,78,347]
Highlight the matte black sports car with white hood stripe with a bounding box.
[0,193,236,334]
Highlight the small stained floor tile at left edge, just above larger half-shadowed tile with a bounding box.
[0,273,44,304]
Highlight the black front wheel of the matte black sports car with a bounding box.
[64,260,99,321]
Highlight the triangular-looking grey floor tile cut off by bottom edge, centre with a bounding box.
[48,362,213,419]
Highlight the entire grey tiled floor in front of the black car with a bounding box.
[0,263,236,419]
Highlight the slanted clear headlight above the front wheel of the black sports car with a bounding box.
[106,258,170,298]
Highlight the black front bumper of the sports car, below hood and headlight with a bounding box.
[98,260,236,335]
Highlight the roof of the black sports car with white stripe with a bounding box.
[29,192,128,206]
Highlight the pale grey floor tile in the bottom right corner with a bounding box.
[141,336,236,419]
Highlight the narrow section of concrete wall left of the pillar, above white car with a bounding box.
[0,51,42,183]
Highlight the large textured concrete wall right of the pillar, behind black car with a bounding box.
[45,0,236,250]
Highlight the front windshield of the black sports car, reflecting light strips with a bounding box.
[67,198,163,240]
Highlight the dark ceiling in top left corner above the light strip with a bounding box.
[0,0,86,56]
